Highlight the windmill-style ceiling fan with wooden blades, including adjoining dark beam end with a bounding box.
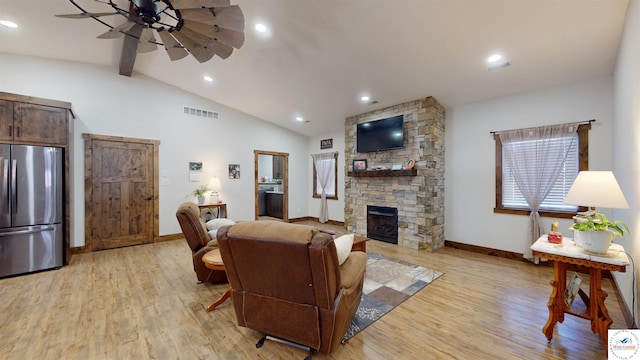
[56,0,244,76]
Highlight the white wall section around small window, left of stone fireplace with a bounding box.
[308,131,346,222]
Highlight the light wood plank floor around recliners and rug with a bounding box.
[0,224,626,360]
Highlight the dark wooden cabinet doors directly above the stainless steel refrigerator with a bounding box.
[0,100,69,146]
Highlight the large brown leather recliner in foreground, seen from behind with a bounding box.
[217,221,367,353]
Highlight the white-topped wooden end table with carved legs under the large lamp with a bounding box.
[531,235,629,348]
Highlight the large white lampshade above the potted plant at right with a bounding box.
[564,171,629,209]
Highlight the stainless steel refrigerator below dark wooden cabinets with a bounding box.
[0,144,64,277]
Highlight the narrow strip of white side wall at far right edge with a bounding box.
[613,0,640,324]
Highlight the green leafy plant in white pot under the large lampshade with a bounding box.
[569,213,629,254]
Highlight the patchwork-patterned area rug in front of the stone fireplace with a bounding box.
[342,252,444,342]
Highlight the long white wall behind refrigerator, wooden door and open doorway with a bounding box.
[0,54,309,246]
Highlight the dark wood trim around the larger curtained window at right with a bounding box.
[493,122,591,219]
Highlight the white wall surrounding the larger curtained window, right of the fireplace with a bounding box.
[445,76,613,253]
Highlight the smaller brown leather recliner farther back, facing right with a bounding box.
[176,202,227,283]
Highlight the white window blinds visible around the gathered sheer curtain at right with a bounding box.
[502,133,579,212]
